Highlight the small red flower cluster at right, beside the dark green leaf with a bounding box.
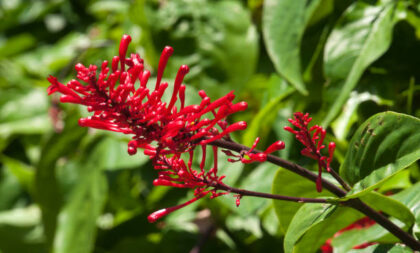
[284,112,335,192]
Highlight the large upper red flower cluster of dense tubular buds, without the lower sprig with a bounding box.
[48,35,247,157]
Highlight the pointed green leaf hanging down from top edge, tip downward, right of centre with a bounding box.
[262,0,321,95]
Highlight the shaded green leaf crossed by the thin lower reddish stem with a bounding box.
[271,168,332,233]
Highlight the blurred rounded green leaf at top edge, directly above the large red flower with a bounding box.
[148,0,259,93]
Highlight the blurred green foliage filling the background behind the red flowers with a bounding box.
[0,0,420,253]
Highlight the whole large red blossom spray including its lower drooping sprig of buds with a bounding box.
[48,35,284,222]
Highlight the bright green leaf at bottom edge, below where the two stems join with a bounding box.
[284,203,362,253]
